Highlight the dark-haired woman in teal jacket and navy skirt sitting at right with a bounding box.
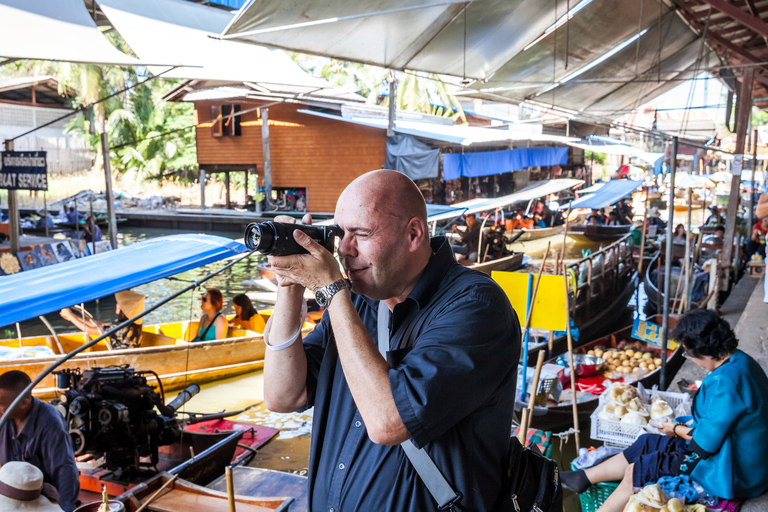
[561,309,768,512]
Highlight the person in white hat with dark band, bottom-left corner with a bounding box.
[0,461,62,512]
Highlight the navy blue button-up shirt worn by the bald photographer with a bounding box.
[304,237,520,512]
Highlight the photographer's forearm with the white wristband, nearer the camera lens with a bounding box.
[264,286,307,412]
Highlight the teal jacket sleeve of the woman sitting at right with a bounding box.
[693,375,747,454]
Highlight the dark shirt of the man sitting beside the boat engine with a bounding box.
[0,398,80,512]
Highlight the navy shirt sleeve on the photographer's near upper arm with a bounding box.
[389,284,520,447]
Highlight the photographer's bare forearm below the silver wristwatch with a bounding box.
[328,293,410,445]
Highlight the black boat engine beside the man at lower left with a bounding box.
[51,365,200,479]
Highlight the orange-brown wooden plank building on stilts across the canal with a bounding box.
[165,81,386,212]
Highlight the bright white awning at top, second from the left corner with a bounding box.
[99,0,359,100]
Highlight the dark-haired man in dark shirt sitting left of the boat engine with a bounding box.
[0,370,80,512]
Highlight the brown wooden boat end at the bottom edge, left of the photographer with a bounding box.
[111,473,293,512]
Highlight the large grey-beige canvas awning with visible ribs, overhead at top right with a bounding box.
[223,0,717,118]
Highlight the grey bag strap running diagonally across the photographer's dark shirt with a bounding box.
[377,300,461,510]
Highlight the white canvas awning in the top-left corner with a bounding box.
[0,0,171,66]
